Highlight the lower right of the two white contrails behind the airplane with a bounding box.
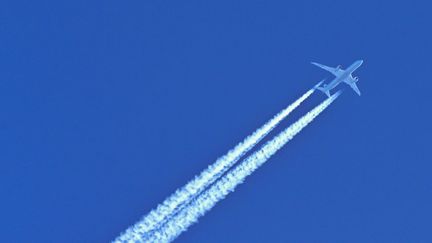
[145,91,341,242]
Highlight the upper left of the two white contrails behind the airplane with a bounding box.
[114,86,321,242]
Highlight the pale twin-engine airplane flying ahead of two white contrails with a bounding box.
[312,60,363,97]
